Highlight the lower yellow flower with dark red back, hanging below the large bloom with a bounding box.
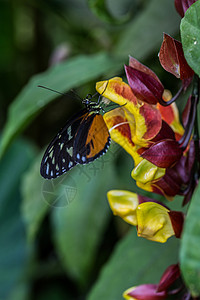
[107,190,184,243]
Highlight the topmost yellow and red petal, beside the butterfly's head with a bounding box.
[96,77,162,147]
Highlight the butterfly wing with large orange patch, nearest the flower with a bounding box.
[73,112,110,164]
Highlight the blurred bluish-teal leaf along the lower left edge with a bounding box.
[0,140,35,300]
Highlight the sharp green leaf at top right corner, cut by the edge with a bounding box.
[181,1,200,76]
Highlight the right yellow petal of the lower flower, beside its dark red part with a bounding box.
[136,202,175,243]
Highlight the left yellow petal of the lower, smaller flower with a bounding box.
[107,190,139,226]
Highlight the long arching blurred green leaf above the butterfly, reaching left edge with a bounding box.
[0,53,121,157]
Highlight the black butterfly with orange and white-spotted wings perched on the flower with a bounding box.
[40,94,111,179]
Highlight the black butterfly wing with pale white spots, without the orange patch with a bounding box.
[40,109,89,179]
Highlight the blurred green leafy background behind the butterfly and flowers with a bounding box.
[0,0,183,300]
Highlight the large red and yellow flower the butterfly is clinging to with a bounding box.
[96,77,191,199]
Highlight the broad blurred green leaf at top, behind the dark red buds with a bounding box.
[115,0,179,60]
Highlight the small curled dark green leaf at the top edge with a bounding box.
[88,0,130,24]
